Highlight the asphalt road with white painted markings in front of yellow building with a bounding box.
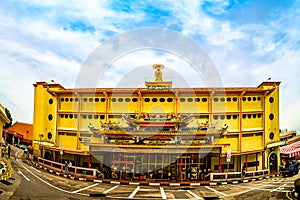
[0,150,299,200]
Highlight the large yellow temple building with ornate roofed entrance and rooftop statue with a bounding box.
[33,64,280,181]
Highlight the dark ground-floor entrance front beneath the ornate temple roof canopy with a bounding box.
[101,152,216,181]
